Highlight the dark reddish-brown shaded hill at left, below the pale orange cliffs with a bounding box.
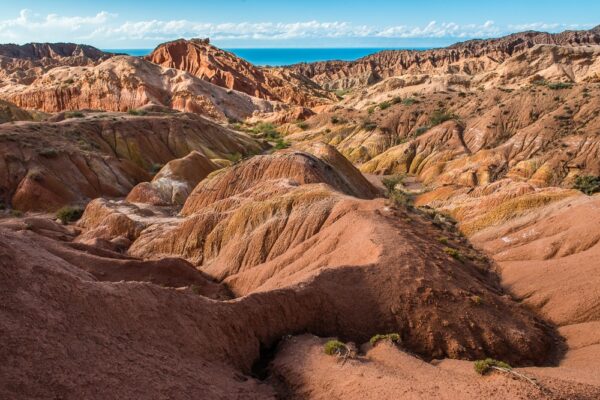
[0,113,262,211]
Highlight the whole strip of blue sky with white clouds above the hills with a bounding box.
[0,0,600,49]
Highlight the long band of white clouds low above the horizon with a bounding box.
[0,10,589,43]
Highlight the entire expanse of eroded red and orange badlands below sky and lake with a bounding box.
[0,28,600,399]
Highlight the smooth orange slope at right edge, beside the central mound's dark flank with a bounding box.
[473,196,600,325]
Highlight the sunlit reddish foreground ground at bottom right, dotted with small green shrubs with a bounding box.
[272,335,600,399]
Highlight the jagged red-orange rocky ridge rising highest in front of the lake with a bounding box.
[146,39,336,107]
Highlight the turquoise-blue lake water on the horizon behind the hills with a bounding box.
[104,48,426,66]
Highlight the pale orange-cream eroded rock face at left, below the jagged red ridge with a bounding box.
[0,56,285,120]
